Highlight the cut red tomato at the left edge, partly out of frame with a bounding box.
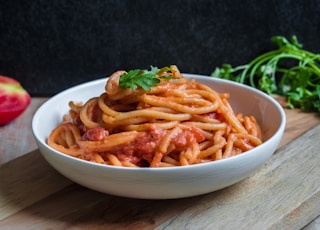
[0,75,31,125]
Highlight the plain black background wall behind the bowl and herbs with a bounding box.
[0,0,320,96]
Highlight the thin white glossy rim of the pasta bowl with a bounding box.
[31,73,286,172]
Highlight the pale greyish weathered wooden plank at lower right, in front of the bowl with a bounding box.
[157,125,320,230]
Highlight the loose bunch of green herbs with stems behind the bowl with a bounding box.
[211,36,320,112]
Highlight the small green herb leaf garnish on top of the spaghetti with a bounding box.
[119,66,171,91]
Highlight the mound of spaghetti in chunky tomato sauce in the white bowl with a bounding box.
[47,66,262,167]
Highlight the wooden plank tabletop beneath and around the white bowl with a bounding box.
[0,98,320,230]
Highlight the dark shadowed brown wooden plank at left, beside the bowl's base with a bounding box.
[0,150,71,220]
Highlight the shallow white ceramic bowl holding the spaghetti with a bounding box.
[32,74,285,199]
